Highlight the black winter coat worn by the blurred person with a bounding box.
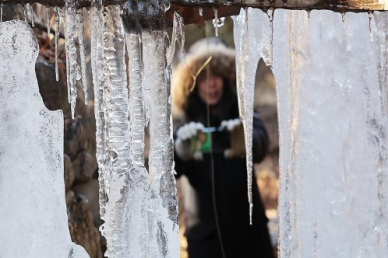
[173,37,273,258]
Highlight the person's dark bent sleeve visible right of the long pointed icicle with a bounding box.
[253,113,269,163]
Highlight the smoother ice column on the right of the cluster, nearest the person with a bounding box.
[142,6,179,257]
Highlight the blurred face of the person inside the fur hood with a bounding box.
[197,75,224,106]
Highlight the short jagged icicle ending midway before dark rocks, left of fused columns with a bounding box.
[65,0,81,119]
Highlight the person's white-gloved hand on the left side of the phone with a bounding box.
[175,122,205,160]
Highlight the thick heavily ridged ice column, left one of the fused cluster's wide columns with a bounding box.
[103,5,135,257]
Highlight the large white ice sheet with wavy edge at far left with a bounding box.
[0,21,89,258]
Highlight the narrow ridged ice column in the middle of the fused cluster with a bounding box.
[125,6,149,258]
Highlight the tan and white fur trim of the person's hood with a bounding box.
[172,38,236,118]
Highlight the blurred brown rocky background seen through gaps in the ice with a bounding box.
[3,4,279,258]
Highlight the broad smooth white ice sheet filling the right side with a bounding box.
[273,10,388,258]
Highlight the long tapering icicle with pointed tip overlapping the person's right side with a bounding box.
[234,8,270,224]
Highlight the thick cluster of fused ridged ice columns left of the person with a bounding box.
[90,3,179,257]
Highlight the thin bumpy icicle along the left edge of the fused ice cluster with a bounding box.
[89,0,109,227]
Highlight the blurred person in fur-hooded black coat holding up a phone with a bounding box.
[172,38,273,258]
